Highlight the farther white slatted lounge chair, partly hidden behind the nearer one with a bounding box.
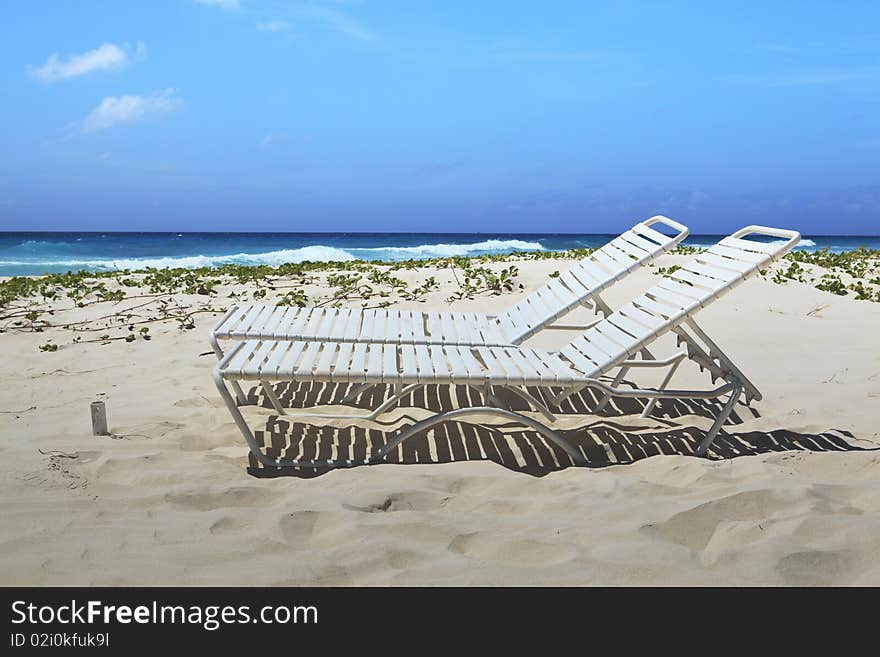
[209,215,688,405]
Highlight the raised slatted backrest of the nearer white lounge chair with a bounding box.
[560,226,801,377]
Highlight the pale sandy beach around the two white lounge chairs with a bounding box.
[0,255,880,586]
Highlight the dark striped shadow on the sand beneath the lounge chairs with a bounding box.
[241,383,880,478]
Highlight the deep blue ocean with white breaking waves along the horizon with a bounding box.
[0,232,868,276]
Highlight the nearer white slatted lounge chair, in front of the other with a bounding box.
[214,226,800,468]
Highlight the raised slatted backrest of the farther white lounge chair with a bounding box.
[496,215,688,344]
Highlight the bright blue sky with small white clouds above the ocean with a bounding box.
[0,0,880,234]
